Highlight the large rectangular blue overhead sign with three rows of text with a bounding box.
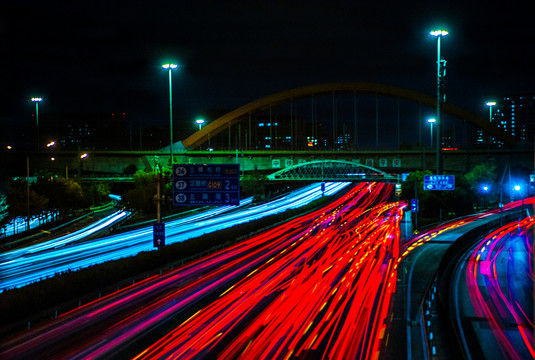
[173,164,240,206]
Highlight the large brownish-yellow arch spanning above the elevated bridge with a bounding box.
[182,83,517,149]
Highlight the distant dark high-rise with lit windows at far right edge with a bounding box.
[476,96,535,147]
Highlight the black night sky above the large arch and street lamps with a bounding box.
[0,0,535,141]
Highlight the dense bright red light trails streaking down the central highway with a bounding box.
[132,184,405,359]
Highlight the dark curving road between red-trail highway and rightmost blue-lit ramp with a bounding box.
[381,208,520,360]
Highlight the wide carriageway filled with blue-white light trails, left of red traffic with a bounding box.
[0,183,349,291]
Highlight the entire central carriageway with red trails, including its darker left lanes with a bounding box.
[1,184,405,359]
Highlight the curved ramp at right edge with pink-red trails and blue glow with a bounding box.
[458,217,535,359]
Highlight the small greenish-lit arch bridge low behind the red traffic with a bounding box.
[267,160,396,181]
